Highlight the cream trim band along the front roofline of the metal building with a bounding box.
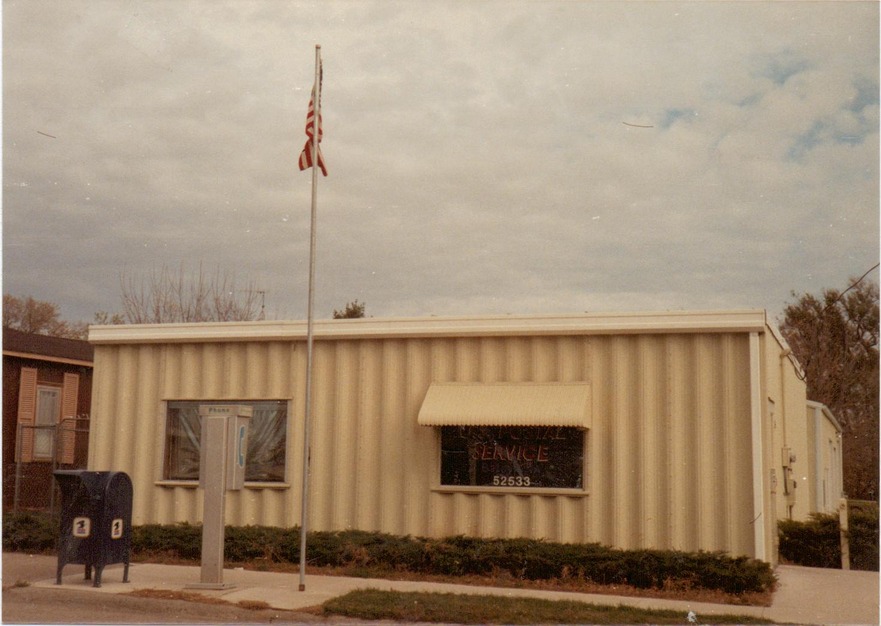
[89,309,767,345]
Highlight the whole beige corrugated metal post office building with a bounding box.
[89,311,840,561]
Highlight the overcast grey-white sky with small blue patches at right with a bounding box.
[2,0,879,321]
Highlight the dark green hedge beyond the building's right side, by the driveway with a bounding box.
[778,506,878,571]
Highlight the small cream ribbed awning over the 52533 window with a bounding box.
[417,382,590,428]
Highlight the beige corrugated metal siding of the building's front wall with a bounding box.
[89,333,753,554]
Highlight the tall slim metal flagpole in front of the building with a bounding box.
[300,44,321,591]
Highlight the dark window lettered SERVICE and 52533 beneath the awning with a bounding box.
[441,426,584,489]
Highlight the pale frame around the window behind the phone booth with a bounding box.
[155,397,293,489]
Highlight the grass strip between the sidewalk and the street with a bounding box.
[323,589,772,624]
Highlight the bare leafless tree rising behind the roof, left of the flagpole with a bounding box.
[120,263,261,324]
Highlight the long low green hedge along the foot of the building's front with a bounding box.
[3,516,775,594]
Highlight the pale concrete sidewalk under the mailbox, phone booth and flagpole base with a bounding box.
[34,563,879,624]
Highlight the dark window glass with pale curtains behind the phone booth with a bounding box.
[164,400,288,482]
